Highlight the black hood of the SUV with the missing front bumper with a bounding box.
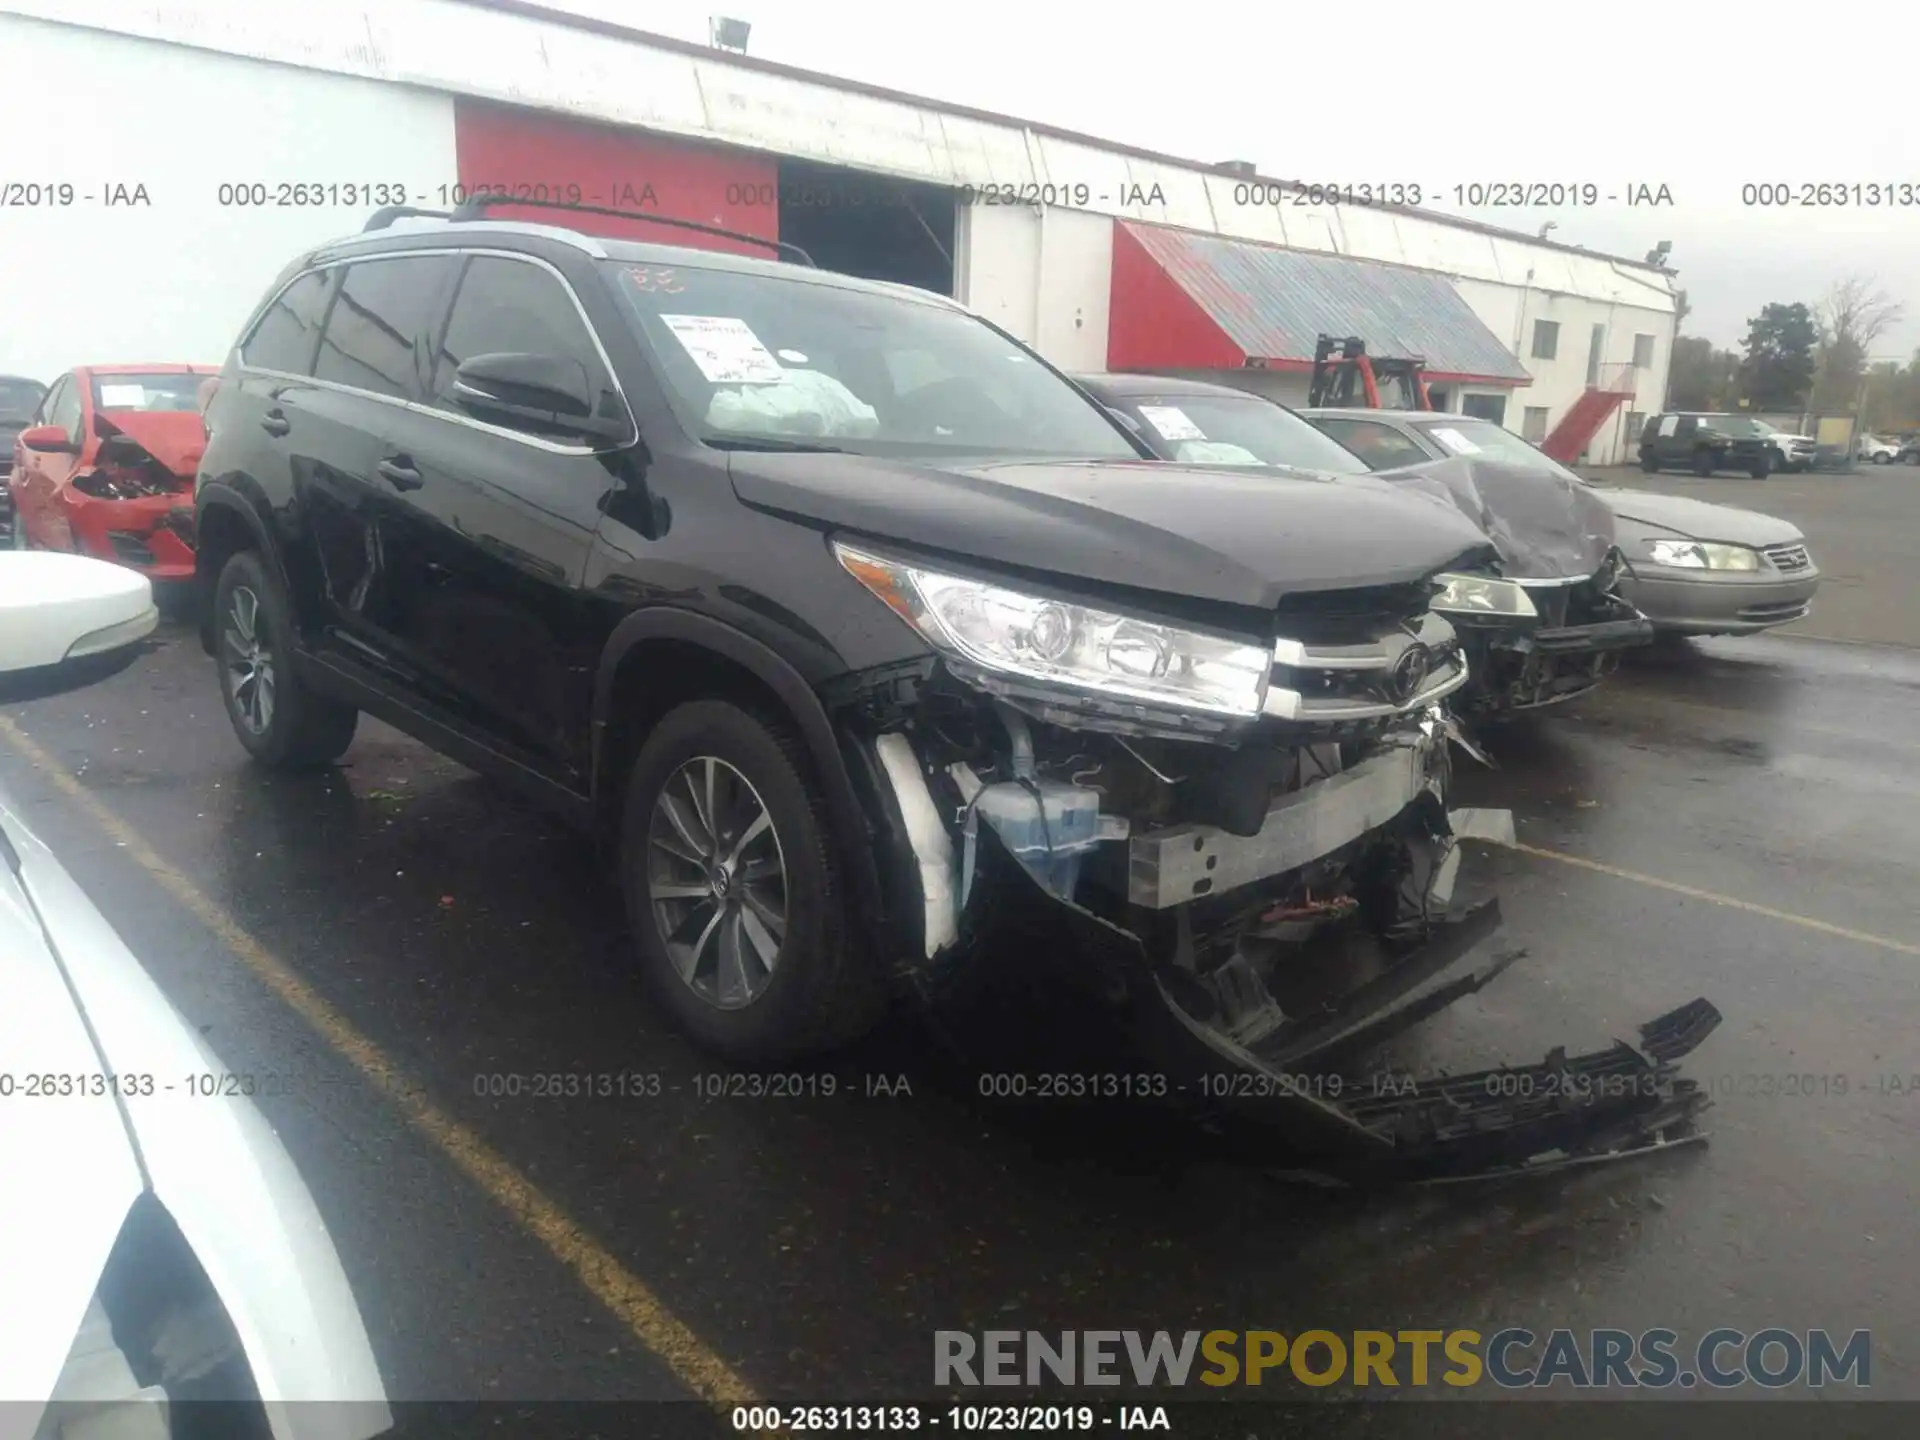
[730,451,1488,611]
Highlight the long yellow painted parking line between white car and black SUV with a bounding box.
[0,714,758,1405]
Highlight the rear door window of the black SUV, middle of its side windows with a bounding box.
[313,255,453,399]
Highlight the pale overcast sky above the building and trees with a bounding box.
[545,0,1920,357]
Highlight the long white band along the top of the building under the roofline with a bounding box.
[0,0,1672,311]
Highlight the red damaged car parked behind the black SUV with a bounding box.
[10,365,219,582]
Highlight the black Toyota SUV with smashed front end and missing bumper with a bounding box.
[196,200,1712,1160]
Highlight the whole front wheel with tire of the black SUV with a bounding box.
[620,701,885,1068]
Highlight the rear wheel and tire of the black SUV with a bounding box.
[213,549,359,772]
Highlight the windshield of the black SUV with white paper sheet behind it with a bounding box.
[605,261,1140,461]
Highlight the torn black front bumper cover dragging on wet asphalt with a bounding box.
[898,760,1720,1187]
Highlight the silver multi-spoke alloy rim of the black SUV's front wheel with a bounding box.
[645,755,787,1010]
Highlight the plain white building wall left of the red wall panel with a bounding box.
[0,15,457,380]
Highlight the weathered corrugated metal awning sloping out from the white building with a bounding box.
[1117,221,1532,384]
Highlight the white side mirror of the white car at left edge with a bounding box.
[0,551,159,699]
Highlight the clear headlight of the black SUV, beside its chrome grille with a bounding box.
[833,543,1273,718]
